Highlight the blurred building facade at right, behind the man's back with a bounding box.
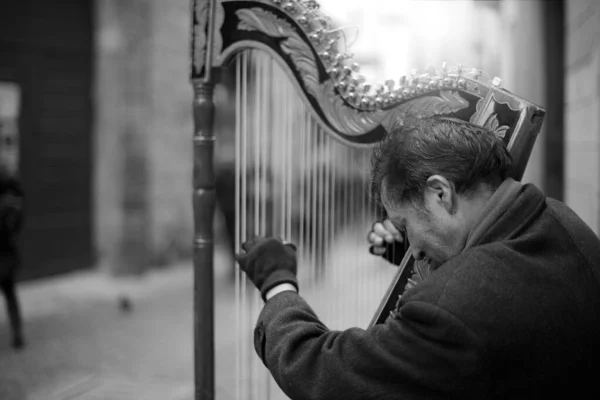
[499,0,600,234]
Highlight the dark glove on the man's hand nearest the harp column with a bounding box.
[235,236,298,301]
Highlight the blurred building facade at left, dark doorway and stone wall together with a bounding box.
[0,0,193,279]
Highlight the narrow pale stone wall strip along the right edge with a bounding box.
[564,0,600,233]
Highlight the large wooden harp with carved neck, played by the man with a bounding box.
[191,0,544,400]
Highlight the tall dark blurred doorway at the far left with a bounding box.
[0,0,93,279]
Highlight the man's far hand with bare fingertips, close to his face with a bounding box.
[367,219,406,265]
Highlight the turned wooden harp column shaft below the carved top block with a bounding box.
[192,79,215,400]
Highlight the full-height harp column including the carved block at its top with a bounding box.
[191,0,219,400]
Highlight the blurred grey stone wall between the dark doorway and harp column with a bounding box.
[94,0,193,274]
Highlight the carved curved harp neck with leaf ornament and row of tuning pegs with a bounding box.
[192,0,544,145]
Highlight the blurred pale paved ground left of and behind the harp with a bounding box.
[0,231,393,400]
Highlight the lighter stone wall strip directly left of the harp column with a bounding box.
[150,0,193,264]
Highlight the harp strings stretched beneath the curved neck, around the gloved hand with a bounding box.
[234,50,395,400]
